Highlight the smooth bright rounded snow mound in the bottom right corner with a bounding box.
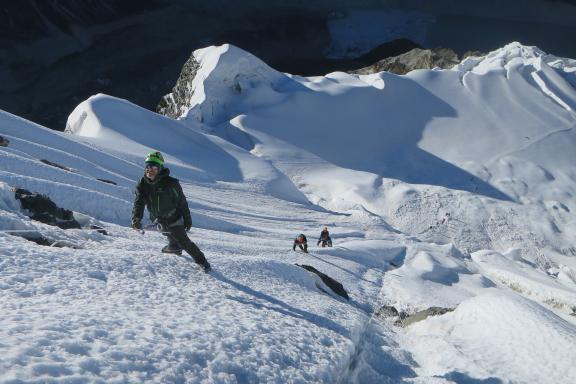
[407,290,576,383]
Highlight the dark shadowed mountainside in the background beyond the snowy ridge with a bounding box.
[0,0,576,130]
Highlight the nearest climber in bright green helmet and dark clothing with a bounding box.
[132,152,210,272]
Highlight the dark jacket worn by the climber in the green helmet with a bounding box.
[132,168,192,227]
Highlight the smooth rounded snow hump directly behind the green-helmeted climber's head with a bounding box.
[67,95,306,202]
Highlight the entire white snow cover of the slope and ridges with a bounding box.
[0,43,576,384]
